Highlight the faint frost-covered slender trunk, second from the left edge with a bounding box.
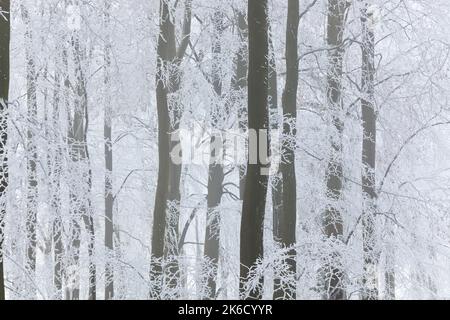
[20,4,38,288]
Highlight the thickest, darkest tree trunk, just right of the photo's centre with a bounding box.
[240,0,269,299]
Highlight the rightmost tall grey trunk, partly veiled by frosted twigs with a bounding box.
[361,2,378,300]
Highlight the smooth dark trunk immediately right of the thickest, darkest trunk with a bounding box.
[274,0,300,299]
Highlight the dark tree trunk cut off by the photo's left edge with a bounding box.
[0,0,11,300]
